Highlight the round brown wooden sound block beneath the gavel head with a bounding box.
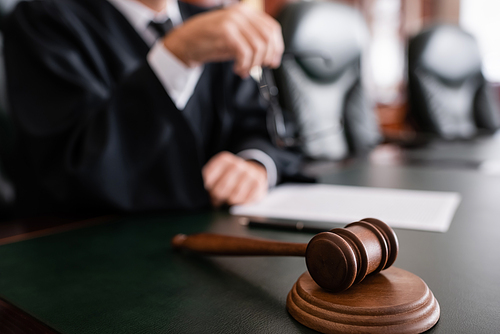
[286,267,440,334]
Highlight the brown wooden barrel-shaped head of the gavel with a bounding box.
[306,218,399,292]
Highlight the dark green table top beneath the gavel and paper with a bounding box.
[0,160,500,333]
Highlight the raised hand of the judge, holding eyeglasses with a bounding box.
[163,4,284,78]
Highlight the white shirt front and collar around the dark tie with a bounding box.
[108,0,182,45]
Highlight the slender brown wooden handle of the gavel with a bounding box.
[172,233,307,256]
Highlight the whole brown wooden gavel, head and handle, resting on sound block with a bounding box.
[172,218,399,292]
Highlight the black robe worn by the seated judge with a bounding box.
[4,0,298,212]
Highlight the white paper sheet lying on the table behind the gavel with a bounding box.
[230,184,460,232]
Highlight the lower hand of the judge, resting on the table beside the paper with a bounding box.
[202,152,268,207]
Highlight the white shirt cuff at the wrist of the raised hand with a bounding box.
[148,39,204,110]
